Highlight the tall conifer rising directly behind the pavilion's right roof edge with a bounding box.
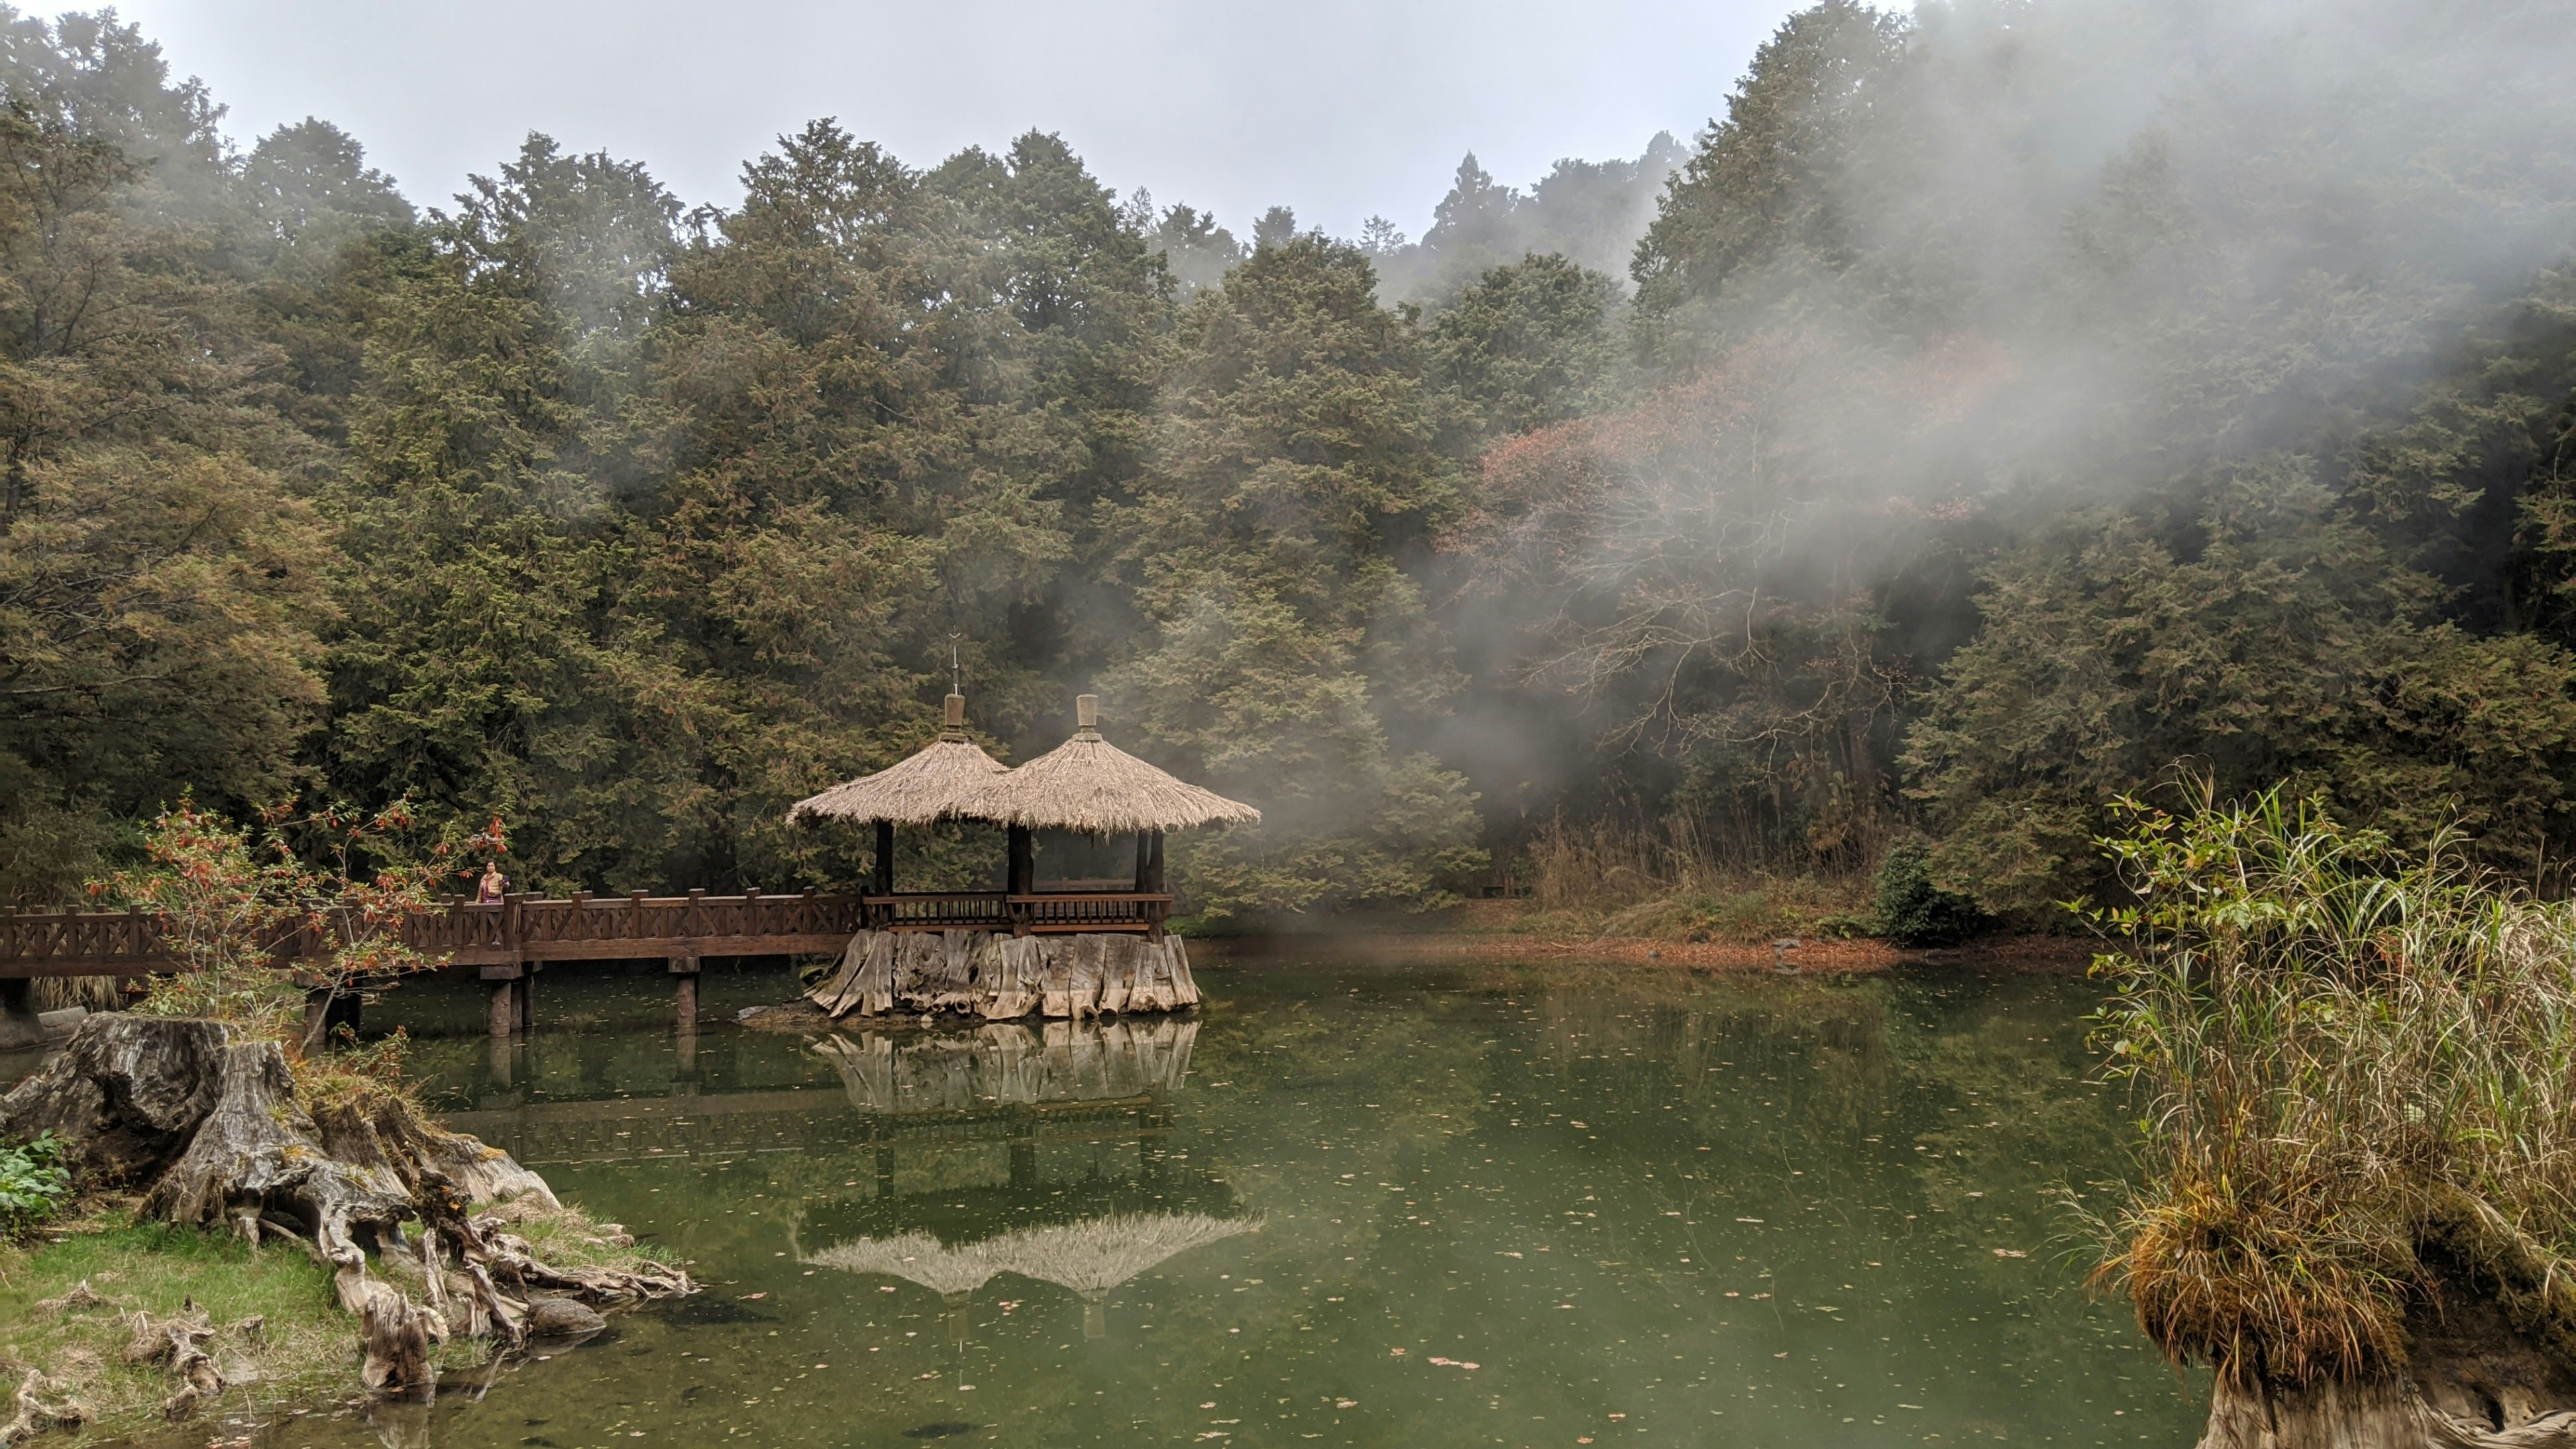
[1110,235,1481,915]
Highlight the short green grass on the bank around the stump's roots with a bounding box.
[0,1199,664,1441]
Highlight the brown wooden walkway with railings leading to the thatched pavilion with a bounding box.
[0,890,1172,1044]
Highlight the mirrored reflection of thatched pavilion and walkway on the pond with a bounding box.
[448,1016,1257,1341]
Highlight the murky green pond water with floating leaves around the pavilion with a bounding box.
[136,959,2205,1449]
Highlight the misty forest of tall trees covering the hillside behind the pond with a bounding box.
[0,0,2576,918]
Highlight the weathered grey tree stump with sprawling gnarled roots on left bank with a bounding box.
[0,1016,693,1415]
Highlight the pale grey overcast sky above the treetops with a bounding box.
[111,0,1790,235]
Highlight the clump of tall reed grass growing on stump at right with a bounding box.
[2092,792,2576,1387]
